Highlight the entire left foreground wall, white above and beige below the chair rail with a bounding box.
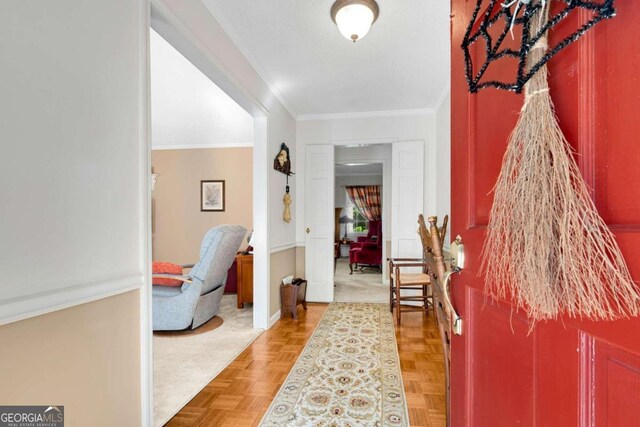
[0,0,150,427]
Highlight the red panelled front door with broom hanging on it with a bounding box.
[451,0,640,427]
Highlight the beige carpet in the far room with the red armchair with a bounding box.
[333,258,389,304]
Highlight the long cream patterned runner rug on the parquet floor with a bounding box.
[260,303,409,427]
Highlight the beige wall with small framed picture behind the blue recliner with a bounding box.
[151,147,253,264]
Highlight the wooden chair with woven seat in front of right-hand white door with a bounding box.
[388,214,448,325]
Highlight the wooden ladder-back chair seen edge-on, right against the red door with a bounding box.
[427,216,456,426]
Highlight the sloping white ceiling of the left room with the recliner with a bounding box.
[150,30,253,149]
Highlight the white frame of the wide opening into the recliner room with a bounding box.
[145,0,271,425]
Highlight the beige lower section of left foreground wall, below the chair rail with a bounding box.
[0,291,141,427]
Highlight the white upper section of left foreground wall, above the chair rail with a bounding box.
[0,0,148,323]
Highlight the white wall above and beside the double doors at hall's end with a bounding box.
[296,110,442,245]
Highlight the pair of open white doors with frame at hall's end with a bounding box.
[305,140,429,302]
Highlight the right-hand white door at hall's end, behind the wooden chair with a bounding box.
[391,141,424,257]
